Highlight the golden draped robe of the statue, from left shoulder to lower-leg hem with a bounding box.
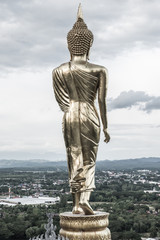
[53,63,100,193]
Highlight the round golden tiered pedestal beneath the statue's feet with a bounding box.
[59,212,111,240]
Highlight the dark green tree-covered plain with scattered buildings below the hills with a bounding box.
[0,170,160,240]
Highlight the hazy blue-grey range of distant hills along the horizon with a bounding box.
[0,157,160,170]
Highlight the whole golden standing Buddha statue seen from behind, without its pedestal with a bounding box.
[53,6,110,215]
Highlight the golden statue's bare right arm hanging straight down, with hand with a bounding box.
[98,68,110,142]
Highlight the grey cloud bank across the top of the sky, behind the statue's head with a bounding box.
[0,0,160,67]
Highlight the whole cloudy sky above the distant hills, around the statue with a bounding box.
[0,0,160,160]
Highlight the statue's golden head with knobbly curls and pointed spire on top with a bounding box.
[67,5,93,57]
